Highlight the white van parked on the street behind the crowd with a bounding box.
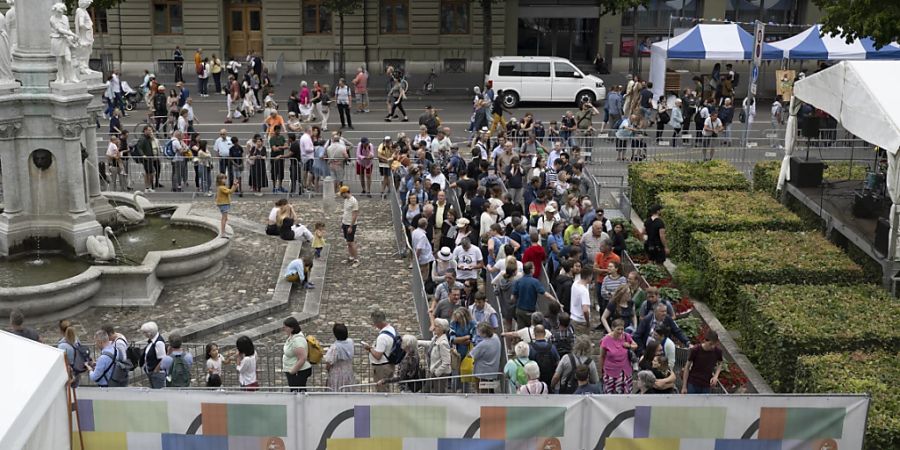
[485,56,606,108]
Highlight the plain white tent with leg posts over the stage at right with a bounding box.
[778,61,900,259]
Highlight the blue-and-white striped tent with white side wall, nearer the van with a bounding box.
[650,23,782,96]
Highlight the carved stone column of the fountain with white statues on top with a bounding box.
[0,0,103,256]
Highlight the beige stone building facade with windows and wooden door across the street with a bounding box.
[4,0,819,73]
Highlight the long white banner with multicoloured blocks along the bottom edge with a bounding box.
[75,389,868,450]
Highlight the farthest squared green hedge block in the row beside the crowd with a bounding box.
[628,160,750,217]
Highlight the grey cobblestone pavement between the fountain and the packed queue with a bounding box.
[29,197,418,356]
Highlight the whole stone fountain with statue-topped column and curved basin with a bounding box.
[0,0,233,317]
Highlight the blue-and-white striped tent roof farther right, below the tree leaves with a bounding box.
[772,25,900,61]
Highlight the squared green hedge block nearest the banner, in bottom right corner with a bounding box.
[795,352,900,450]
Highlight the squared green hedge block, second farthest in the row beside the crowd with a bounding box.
[658,191,809,260]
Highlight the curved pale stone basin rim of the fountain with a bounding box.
[0,199,233,319]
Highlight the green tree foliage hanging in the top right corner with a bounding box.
[813,0,900,48]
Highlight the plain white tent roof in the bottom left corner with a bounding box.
[0,331,70,450]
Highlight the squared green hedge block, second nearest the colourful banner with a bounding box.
[739,284,900,392]
